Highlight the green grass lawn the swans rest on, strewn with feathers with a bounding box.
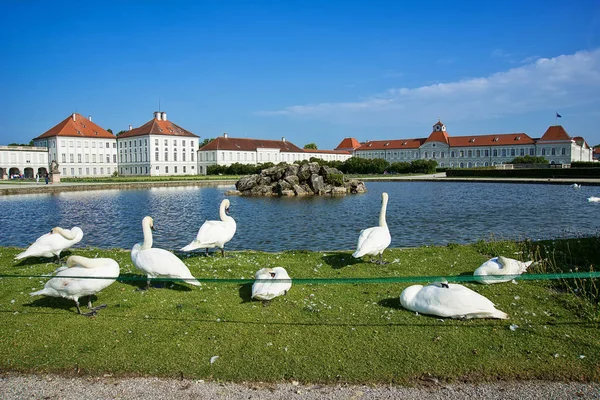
[0,238,600,383]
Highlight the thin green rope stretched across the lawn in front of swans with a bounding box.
[0,271,600,285]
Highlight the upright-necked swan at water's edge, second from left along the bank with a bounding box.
[181,199,236,257]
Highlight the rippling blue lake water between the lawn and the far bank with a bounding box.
[0,182,600,251]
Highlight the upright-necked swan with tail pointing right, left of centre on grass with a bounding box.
[131,217,200,289]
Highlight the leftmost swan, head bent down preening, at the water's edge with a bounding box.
[15,226,83,263]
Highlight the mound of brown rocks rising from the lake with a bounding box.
[226,162,367,196]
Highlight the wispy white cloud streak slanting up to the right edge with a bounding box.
[257,49,600,124]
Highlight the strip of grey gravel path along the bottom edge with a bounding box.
[0,374,600,400]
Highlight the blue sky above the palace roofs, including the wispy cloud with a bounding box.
[0,0,600,149]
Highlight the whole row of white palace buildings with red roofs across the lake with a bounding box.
[0,115,594,179]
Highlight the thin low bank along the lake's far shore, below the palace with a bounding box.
[0,173,600,196]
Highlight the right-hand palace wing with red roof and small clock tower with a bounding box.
[336,121,593,168]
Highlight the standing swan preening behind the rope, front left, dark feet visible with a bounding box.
[30,256,120,316]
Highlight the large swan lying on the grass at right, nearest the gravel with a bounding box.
[400,282,508,319]
